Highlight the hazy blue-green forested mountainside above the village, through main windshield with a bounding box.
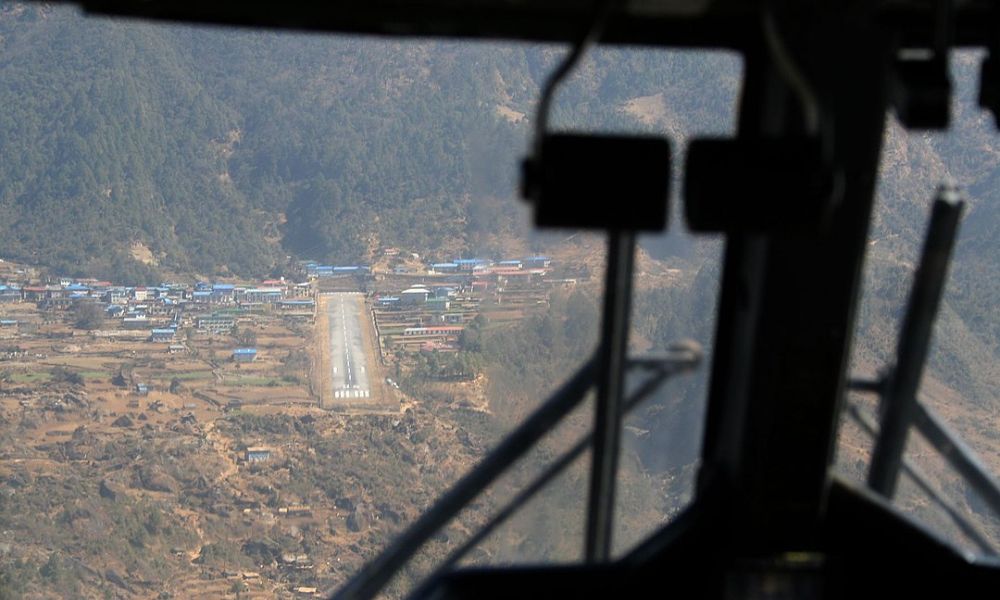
[0,4,735,277]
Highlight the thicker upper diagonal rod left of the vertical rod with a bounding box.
[334,357,597,600]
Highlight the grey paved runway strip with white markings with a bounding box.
[326,294,371,400]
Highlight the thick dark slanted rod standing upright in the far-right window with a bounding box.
[868,185,964,498]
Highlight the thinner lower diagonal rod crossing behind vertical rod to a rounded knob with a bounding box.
[410,353,701,598]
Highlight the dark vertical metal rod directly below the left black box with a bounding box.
[585,231,635,563]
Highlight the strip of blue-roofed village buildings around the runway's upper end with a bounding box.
[0,249,577,362]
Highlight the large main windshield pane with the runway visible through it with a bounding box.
[0,2,741,597]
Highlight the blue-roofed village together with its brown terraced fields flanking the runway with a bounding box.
[0,248,587,408]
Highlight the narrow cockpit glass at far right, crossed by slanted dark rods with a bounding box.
[837,51,1000,554]
